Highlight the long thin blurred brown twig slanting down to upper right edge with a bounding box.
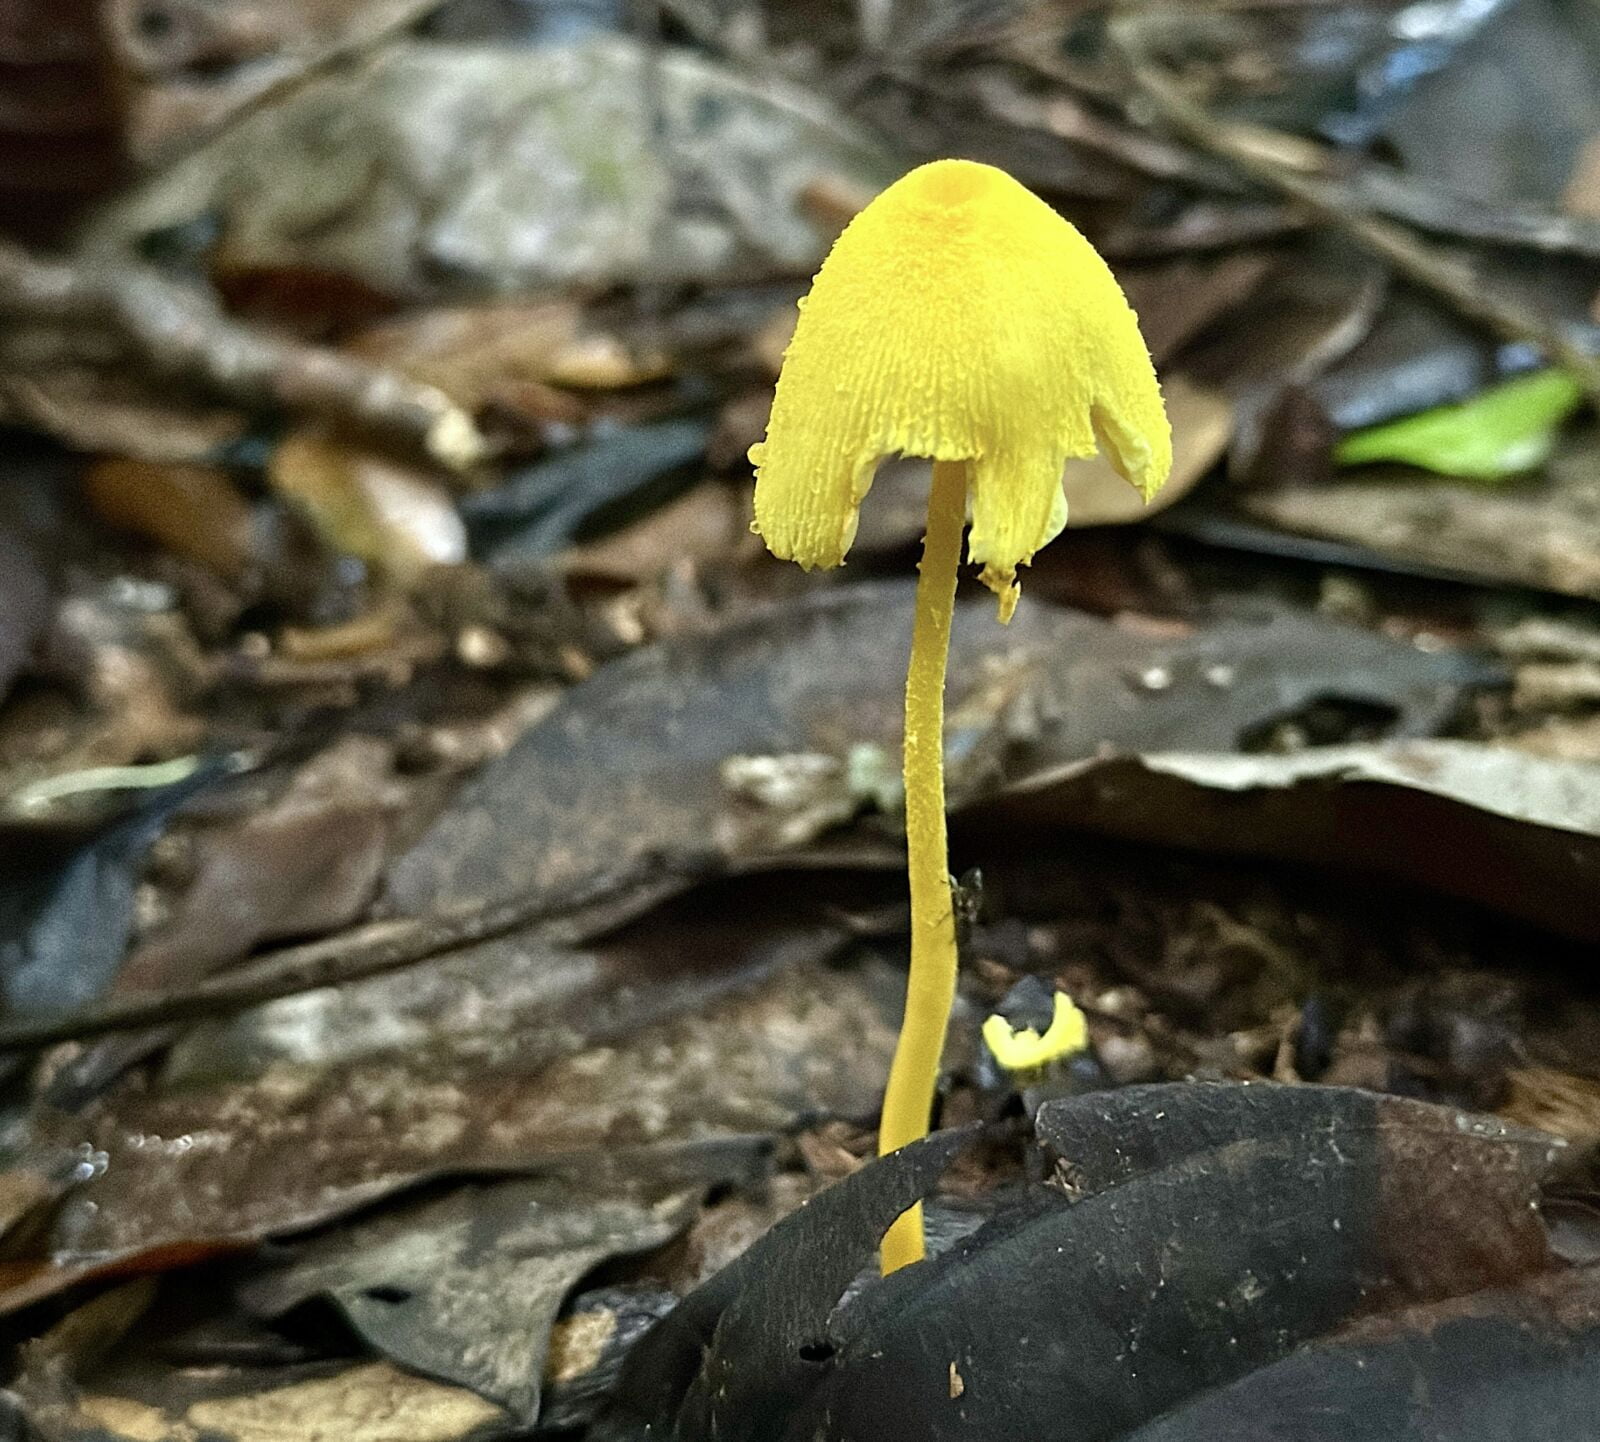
[1109,19,1600,403]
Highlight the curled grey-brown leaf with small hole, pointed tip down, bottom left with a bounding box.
[242,1171,736,1426]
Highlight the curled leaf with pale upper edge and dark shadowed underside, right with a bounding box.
[971,741,1600,941]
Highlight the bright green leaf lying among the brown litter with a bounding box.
[1333,370,1584,480]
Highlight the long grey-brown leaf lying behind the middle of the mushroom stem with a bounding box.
[389,583,1491,912]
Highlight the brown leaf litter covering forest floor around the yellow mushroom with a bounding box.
[0,0,1600,1442]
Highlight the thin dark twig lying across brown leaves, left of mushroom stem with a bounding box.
[0,855,720,1053]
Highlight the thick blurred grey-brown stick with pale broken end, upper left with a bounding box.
[0,242,486,471]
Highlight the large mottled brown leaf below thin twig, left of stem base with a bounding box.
[0,907,898,1309]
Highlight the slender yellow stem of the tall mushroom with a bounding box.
[878,461,966,1274]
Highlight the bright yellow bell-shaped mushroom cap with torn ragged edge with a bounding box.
[750,160,1173,616]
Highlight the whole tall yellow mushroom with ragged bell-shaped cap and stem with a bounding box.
[750,160,1171,1272]
